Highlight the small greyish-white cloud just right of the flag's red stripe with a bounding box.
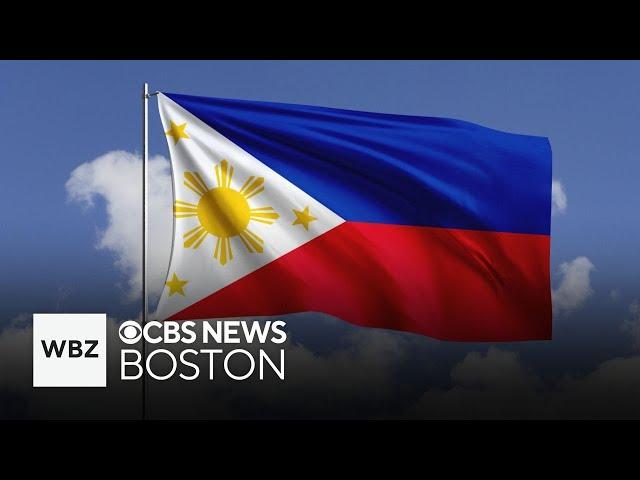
[551,257,595,315]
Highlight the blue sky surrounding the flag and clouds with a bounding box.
[0,61,640,418]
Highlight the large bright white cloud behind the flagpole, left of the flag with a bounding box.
[66,151,173,301]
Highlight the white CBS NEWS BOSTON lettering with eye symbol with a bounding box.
[119,320,287,381]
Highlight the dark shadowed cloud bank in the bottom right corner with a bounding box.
[407,348,640,419]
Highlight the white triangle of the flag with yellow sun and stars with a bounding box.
[155,93,344,320]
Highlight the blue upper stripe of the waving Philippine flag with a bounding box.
[166,93,551,234]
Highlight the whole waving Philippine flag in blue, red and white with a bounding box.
[151,93,551,341]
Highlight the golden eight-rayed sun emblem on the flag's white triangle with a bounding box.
[173,160,280,265]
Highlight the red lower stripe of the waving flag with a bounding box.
[171,222,551,341]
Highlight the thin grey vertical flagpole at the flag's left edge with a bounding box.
[141,82,149,420]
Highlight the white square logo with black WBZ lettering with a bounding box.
[33,313,107,387]
